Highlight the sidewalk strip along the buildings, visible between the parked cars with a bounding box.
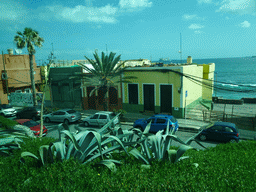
[81,110,256,140]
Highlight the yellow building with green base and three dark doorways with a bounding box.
[122,63,215,118]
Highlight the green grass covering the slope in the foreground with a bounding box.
[0,138,256,191]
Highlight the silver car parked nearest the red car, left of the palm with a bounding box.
[43,109,82,124]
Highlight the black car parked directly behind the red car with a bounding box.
[16,105,41,121]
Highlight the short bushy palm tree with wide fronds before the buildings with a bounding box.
[78,51,135,111]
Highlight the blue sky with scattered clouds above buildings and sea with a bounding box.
[0,0,256,62]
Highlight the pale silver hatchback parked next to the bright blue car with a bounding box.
[82,111,120,127]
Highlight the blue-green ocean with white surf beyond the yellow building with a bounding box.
[155,57,256,99]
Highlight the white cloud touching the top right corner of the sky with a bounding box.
[216,0,256,15]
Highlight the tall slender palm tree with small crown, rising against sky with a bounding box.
[14,27,44,106]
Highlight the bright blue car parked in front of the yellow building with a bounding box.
[133,114,179,133]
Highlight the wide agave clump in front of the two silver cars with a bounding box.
[21,114,132,170]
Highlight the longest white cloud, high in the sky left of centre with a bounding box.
[44,5,118,23]
